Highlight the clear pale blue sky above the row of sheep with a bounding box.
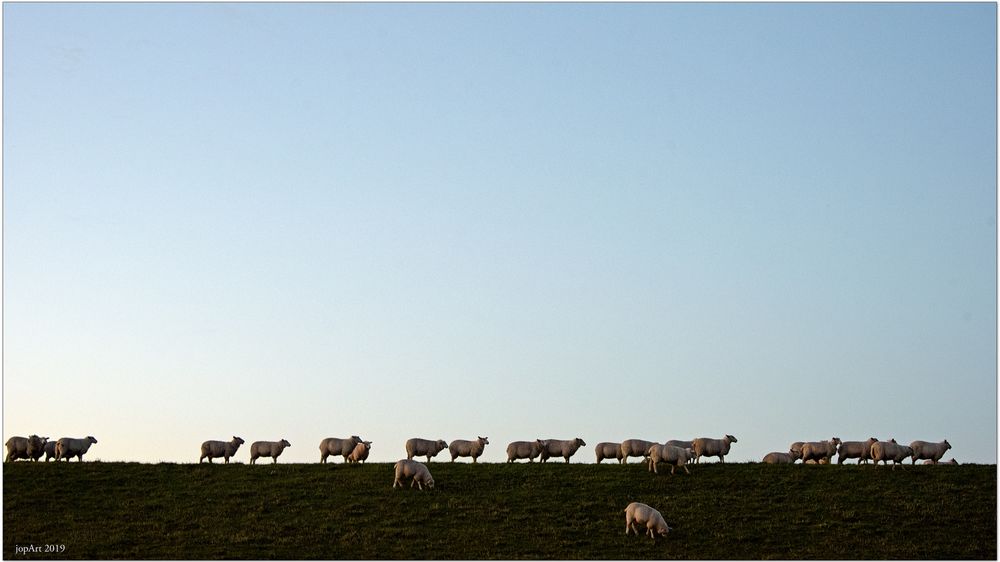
[2,2,997,463]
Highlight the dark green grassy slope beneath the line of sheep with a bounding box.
[3,462,997,560]
